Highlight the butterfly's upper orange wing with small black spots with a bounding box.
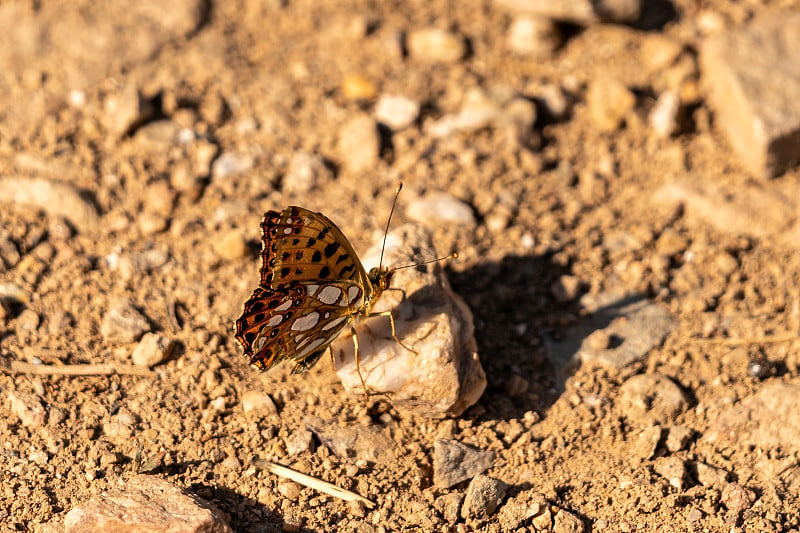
[261,206,370,296]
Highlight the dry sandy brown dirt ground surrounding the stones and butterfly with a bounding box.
[0,0,800,532]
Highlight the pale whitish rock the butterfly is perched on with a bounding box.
[332,224,486,418]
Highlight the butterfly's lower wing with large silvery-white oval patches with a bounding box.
[236,280,363,373]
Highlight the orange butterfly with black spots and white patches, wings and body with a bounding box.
[236,206,393,373]
